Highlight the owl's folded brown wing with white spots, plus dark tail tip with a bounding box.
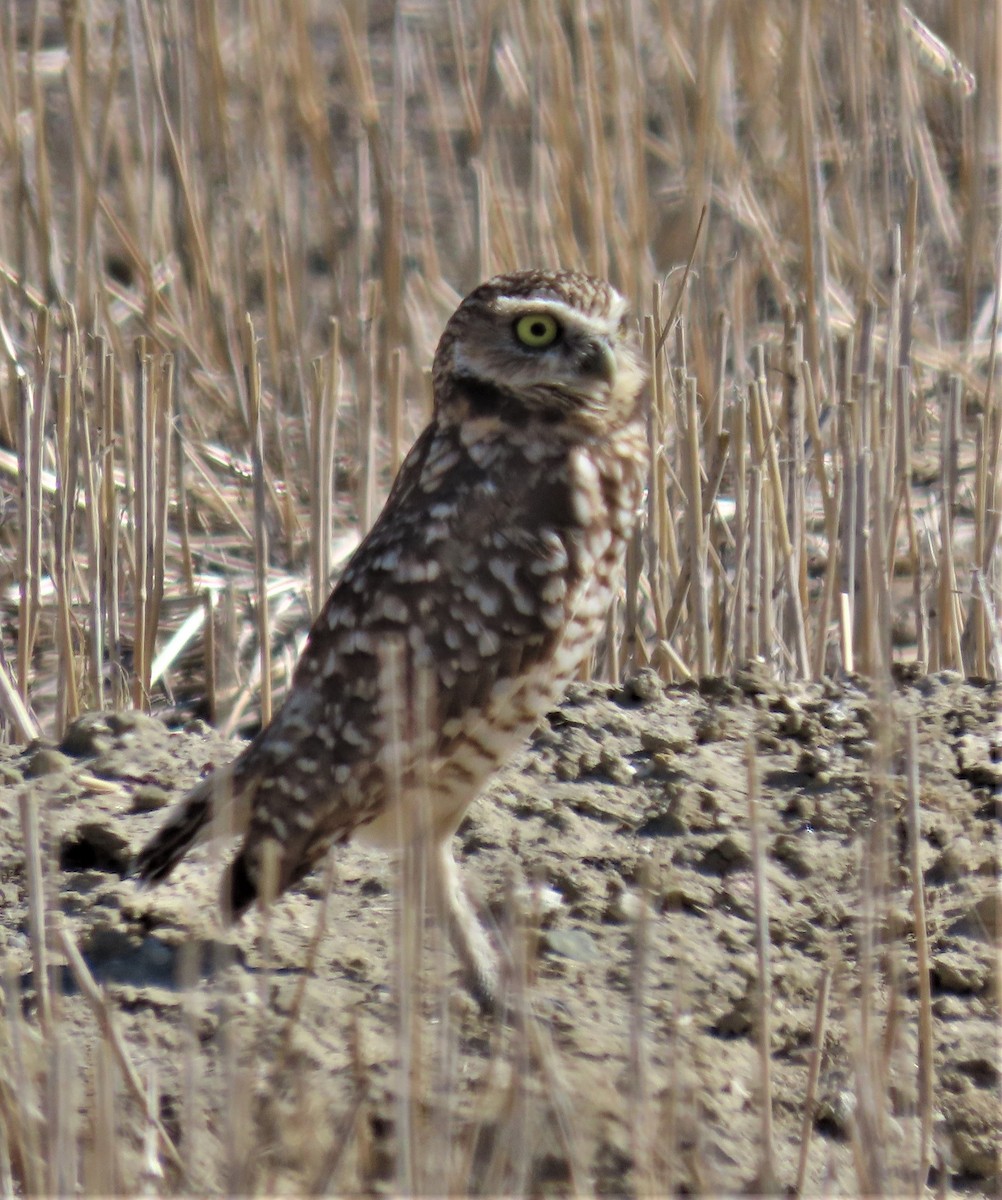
[139,424,582,917]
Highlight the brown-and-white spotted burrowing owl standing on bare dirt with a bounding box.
[137,270,647,1003]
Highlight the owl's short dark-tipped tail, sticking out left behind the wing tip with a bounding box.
[133,760,246,883]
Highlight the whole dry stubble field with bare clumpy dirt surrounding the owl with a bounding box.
[0,0,1002,1195]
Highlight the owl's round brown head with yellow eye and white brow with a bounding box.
[433,270,647,430]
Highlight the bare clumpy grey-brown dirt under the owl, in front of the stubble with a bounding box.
[0,670,1002,1195]
